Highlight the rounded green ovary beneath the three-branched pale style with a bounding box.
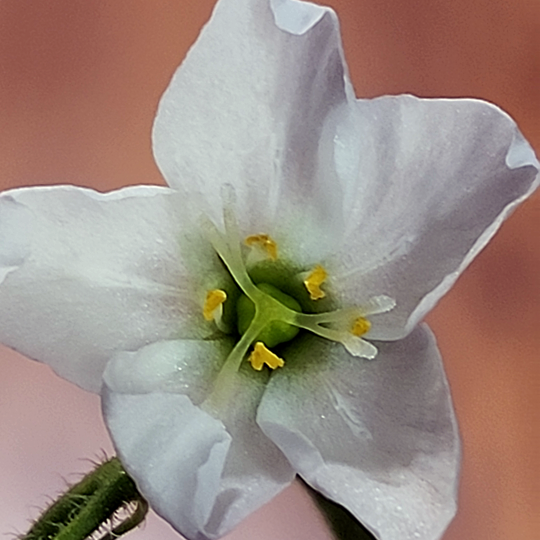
[236,283,302,348]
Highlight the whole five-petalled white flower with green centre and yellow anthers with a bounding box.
[0,0,539,540]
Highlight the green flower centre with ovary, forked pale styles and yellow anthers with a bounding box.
[203,209,395,376]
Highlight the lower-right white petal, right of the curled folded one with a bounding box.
[257,327,459,540]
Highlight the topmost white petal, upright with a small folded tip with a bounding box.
[154,0,350,255]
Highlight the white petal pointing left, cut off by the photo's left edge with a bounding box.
[0,186,207,392]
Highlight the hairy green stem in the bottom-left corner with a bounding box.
[21,458,148,540]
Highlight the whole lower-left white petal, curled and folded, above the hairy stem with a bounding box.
[102,340,294,540]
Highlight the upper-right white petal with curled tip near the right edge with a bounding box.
[329,96,540,340]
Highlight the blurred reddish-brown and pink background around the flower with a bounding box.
[0,0,540,540]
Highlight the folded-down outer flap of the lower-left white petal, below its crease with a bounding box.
[103,392,231,539]
